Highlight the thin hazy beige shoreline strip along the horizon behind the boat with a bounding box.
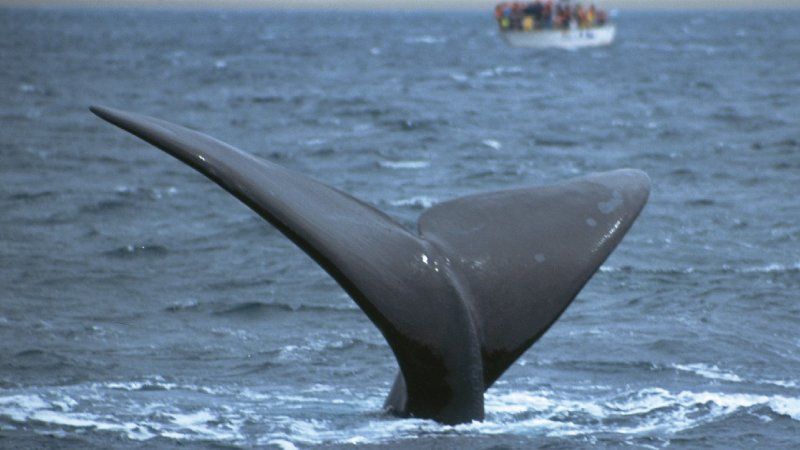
[0,0,800,11]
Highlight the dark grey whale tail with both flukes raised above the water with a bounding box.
[90,106,650,424]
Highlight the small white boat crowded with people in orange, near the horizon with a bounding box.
[495,0,616,49]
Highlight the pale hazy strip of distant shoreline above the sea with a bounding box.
[0,0,800,9]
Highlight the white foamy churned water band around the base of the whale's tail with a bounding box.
[0,384,800,448]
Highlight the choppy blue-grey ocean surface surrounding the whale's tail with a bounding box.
[0,9,800,449]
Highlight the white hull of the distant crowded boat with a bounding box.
[501,25,617,49]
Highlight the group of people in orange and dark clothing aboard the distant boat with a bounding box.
[494,0,608,31]
